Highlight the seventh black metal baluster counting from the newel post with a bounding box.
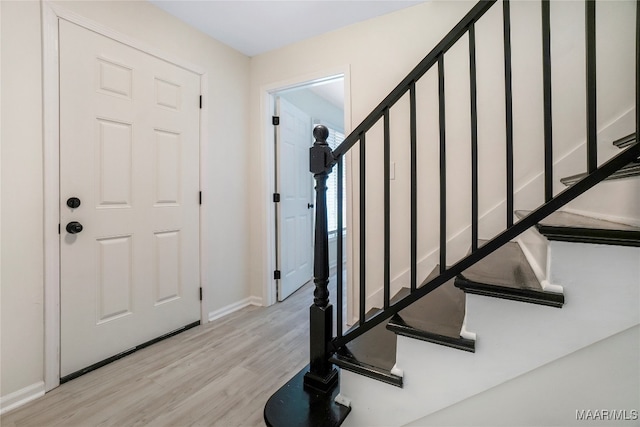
[502,0,514,228]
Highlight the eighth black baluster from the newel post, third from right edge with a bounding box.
[541,0,553,202]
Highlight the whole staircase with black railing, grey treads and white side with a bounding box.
[265,0,640,426]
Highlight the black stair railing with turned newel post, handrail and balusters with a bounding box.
[305,0,640,391]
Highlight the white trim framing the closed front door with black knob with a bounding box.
[41,0,208,391]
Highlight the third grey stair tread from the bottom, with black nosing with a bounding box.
[455,242,564,307]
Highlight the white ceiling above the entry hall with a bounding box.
[149,0,426,56]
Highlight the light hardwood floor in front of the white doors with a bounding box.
[0,284,324,427]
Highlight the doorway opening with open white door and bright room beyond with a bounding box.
[270,75,347,301]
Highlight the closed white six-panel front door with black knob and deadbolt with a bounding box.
[60,20,200,377]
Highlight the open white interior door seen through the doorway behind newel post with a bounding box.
[277,98,313,301]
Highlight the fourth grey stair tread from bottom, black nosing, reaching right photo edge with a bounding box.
[516,211,640,247]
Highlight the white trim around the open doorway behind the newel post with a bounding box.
[260,65,353,306]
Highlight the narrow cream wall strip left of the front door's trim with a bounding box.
[0,2,44,404]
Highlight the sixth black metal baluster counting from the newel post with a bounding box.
[469,24,478,252]
